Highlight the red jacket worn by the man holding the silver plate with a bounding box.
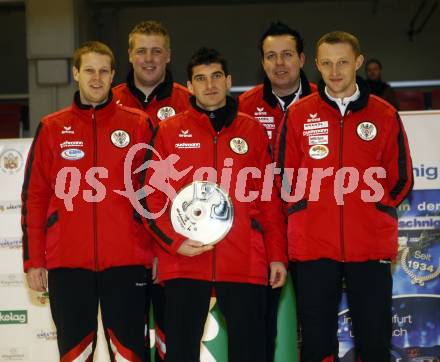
[145,98,287,284]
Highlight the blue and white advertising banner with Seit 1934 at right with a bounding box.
[338,111,440,362]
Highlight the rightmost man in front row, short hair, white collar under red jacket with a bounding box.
[277,31,413,362]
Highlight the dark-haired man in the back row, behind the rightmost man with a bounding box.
[239,21,316,362]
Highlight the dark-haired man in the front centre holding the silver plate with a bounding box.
[145,48,286,362]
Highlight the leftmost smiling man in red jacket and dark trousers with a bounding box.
[22,42,151,361]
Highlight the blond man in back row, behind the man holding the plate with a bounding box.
[113,20,190,362]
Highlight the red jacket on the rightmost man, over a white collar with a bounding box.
[276,78,413,261]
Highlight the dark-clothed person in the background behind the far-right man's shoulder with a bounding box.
[365,58,399,109]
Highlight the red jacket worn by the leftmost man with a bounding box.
[22,93,152,271]
